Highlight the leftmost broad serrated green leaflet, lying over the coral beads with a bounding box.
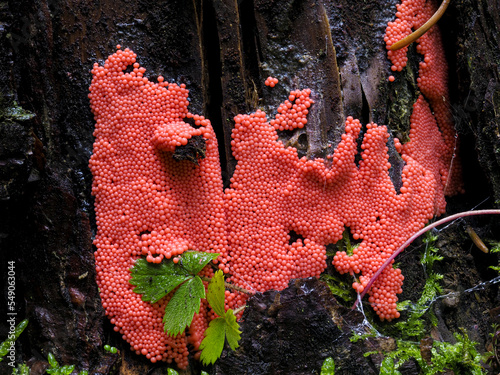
[129,258,192,303]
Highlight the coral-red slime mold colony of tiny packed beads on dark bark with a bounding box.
[89,0,461,368]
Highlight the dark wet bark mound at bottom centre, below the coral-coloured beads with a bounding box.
[213,278,388,375]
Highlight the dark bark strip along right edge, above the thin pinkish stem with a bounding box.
[454,0,500,206]
